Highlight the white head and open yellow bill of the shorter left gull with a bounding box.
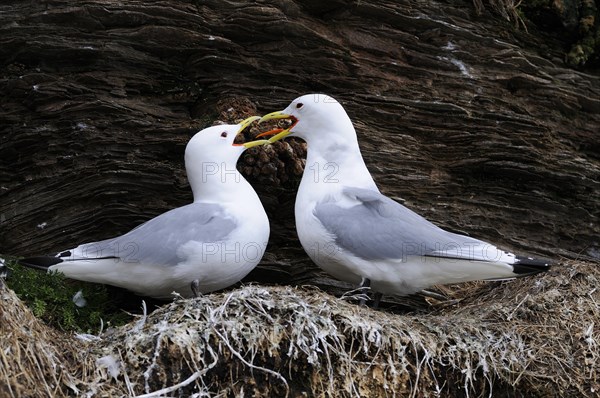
[185,116,267,200]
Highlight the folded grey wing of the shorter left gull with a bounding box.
[69,203,236,265]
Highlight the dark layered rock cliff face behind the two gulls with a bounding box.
[0,0,600,284]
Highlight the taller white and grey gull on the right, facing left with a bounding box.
[259,94,549,297]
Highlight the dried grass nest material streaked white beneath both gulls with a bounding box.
[0,262,600,397]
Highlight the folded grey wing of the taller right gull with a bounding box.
[314,188,485,260]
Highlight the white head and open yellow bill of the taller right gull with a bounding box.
[259,94,356,145]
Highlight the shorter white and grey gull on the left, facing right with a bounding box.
[20,116,270,298]
